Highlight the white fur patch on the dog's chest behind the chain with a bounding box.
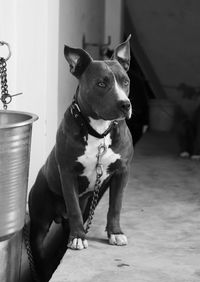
[77,134,121,192]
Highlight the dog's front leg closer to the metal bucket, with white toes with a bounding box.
[60,166,88,250]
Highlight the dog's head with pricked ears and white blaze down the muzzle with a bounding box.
[64,35,132,120]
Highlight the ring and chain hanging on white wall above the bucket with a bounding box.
[0,41,22,110]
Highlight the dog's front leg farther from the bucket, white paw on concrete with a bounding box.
[106,170,128,246]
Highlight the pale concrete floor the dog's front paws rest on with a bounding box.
[51,132,200,282]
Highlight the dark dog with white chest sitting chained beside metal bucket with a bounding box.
[28,36,133,281]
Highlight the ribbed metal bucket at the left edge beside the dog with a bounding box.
[0,111,38,241]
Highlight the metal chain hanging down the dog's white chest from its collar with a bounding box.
[85,139,107,234]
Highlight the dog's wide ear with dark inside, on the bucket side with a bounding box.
[64,45,92,78]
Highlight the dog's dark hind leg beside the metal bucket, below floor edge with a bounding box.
[29,170,54,281]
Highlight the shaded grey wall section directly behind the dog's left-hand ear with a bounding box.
[58,0,104,123]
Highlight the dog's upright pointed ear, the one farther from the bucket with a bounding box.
[112,34,131,71]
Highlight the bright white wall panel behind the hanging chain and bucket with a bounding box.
[0,0,59,189]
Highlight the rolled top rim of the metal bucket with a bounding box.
[0,110,39,129]
